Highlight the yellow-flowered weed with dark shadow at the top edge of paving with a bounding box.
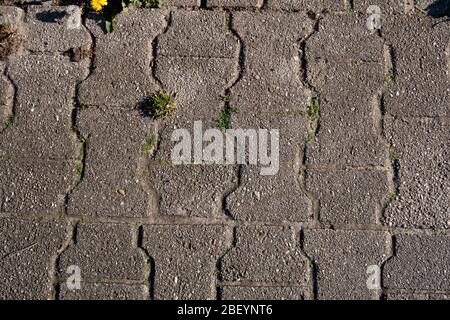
[89,0,162,32]
